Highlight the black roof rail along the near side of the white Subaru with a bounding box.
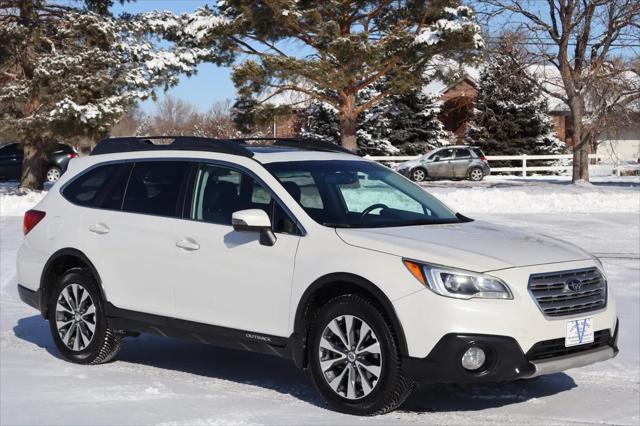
[90,136,253,157]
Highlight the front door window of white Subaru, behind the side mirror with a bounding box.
[190,164,299,234]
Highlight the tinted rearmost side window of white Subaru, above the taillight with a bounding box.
[62,164,131,210]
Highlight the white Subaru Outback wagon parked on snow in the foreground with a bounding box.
[18,137,618,415]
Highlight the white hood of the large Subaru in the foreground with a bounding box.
[336,221,592,272]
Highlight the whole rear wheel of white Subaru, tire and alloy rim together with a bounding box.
[48,268,124,364]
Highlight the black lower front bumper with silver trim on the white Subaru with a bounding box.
[403,323,618,383]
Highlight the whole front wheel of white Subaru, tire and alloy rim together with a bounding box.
[308,294,413,415]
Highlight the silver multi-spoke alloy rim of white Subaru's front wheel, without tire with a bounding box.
[318,315,382,400]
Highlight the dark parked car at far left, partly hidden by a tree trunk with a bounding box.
[0,143,78,182]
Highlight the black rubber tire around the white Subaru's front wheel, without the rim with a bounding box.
[307,294,413,416]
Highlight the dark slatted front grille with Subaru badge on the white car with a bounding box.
[529,268,607,317]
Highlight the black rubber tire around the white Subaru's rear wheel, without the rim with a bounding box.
[48,268,124,364]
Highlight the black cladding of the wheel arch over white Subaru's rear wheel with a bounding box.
[40,248,106,318]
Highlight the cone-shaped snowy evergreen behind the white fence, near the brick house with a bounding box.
[467,38,564,155]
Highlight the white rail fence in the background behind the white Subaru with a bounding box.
[366,154,604,176]
